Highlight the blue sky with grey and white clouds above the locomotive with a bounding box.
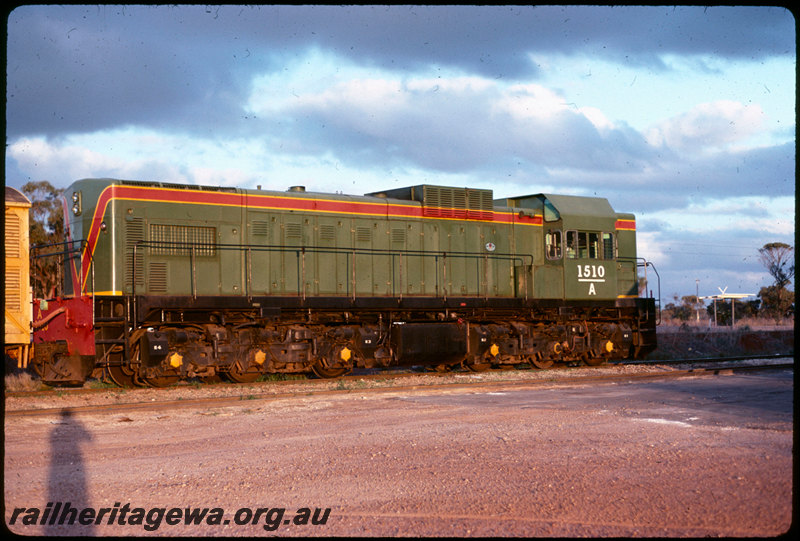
[5,5,796,302]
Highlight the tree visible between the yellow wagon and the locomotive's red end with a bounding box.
[22,180,64,298]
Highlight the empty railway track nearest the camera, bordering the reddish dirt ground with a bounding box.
[5,355,794,417]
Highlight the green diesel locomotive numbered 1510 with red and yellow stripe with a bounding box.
[31,179,657,386]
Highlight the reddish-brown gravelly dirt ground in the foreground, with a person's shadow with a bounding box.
[4,373,793,537]
